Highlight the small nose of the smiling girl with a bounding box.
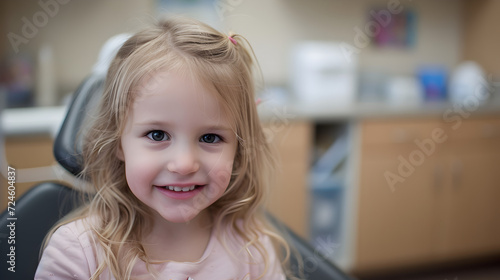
[167,145,200,175]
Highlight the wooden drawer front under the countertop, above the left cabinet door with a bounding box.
[362,120,444,145]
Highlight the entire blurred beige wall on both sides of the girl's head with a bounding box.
[0,0,462,103]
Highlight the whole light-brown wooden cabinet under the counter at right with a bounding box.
[355,119,500,271]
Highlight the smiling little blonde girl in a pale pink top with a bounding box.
[35,19,288,280]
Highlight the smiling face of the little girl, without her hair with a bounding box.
[117,72,237,223]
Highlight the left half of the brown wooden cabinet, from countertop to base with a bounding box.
[356,121,445,270]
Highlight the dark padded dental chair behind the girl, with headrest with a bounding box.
[0,37,354,280]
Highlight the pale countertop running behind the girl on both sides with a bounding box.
[0,98,500,137]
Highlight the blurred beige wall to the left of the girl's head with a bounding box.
[0,0,153,102]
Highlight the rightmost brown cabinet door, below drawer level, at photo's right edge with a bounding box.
[441,147,500,258]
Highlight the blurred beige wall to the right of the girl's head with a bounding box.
[225,0,462,84]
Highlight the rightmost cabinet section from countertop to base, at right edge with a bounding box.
[440,119,500,258]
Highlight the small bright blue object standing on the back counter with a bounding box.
[417,66,447,101]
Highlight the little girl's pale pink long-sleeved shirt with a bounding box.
[35,220,286,280]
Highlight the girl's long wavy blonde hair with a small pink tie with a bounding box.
[46,18,289,279]
